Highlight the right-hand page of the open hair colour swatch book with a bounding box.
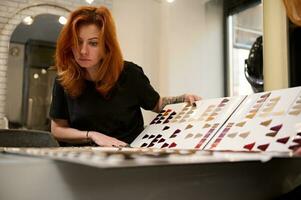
[205,87,301,151]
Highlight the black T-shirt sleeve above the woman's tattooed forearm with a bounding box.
[136,67,160,110]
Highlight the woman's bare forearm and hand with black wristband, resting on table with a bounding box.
[51,119,127,147]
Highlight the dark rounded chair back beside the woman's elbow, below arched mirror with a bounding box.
[0,129,59,147]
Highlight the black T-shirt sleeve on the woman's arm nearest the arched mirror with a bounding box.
[49,78,69,120]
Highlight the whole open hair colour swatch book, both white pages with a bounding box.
[131,87,301,151]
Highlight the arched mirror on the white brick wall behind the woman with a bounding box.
[6,14,62,130]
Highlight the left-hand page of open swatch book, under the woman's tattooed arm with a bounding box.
[131,96,246,149]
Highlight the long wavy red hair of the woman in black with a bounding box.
[55,6,123,97]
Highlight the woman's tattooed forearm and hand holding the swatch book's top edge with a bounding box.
[153,94,202,113]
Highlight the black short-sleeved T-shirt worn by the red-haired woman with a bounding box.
[50,61,160,143]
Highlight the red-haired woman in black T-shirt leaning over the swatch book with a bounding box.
[50,7,200,147]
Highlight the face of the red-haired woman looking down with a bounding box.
[72,24,105,70]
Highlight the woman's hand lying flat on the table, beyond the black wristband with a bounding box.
[89,131,127,147]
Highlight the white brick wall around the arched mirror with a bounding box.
[0,0,112,117]
